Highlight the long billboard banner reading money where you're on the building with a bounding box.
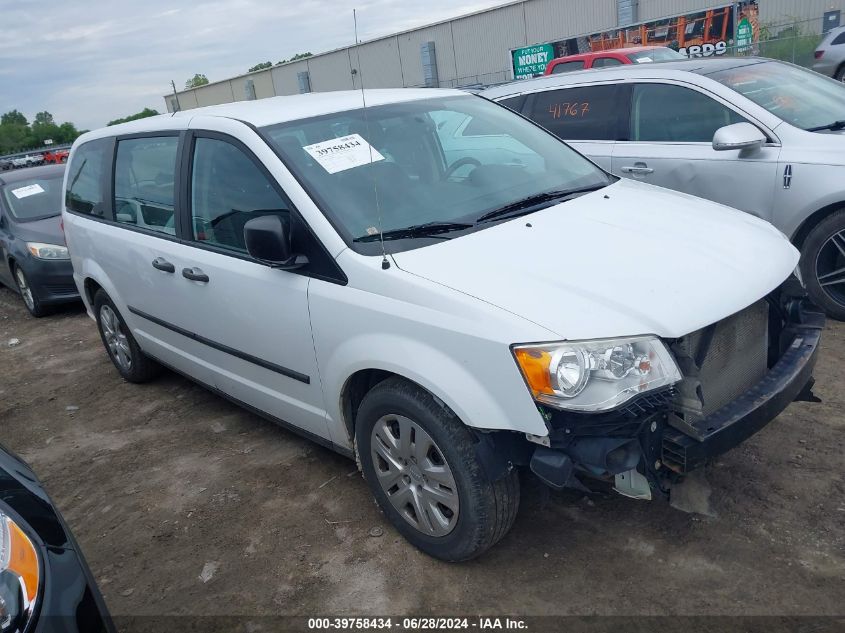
[512,0,760,79]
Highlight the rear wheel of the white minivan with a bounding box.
[94,290,162,383]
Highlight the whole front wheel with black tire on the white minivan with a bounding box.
[355,378,519,561]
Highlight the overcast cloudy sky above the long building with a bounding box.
[0,0,506,129]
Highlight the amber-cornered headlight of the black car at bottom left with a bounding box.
[0,510,39,633]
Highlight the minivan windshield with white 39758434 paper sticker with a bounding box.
[263,95,612,254]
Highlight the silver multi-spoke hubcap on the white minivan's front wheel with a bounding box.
[370,415,459,536]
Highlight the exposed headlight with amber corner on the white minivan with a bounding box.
[512,336,682,411]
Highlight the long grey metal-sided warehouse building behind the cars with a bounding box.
[164,0,845,112]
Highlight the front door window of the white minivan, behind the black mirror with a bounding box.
[191,138,289,253]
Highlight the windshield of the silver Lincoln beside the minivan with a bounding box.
[708,61,845,130]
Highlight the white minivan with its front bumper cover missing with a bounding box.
[63,90,824,560]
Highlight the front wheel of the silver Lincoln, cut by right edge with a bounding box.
[801,209,845,321]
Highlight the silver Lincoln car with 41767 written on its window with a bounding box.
[482,58,845,320]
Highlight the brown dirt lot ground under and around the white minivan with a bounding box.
[0,290,845,616]
